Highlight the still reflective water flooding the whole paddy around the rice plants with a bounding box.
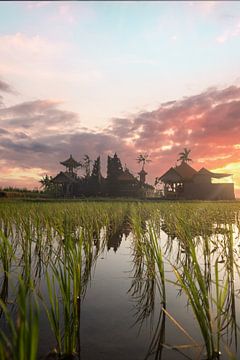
[0,202,240,360]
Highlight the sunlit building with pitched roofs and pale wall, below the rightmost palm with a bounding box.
[159,162,235,200]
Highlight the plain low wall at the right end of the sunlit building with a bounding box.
[182,182,235,200]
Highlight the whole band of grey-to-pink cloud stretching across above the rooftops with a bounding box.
[0,81,240,195]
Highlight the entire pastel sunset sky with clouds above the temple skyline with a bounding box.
[0,1,240,197]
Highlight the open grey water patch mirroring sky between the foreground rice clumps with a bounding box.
[81,236,198,360]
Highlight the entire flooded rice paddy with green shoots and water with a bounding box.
[0,201,240,360]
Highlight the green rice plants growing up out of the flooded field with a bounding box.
[0,201,240,360]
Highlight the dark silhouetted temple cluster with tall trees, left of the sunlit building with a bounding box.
[51,153,154,197]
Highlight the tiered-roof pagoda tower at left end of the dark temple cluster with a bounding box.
[52,155,81,196]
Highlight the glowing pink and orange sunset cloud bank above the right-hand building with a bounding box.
[107,86,240,186]
